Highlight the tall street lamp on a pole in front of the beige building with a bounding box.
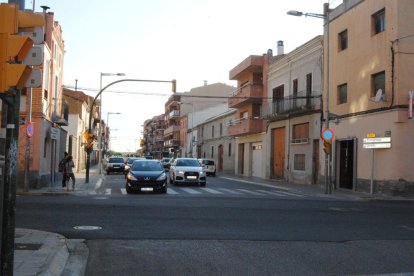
[287,3,332,194]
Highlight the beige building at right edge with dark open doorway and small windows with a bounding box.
[322,0,414,195]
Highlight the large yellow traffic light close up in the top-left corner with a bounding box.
[0,3,45,93]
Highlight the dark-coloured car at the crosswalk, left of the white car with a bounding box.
[125,159,167,194]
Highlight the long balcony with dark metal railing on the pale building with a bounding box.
[260,95,321,121]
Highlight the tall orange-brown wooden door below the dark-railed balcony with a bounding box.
[272,127,286,178]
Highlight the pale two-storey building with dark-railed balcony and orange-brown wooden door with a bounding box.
[260,36,323,184]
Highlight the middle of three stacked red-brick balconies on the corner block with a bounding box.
[229,83,263,108]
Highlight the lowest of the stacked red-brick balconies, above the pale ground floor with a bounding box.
[227,118,266,136]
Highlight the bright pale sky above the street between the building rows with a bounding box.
[0,0,342,151]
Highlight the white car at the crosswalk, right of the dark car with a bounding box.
[169,158,207,186]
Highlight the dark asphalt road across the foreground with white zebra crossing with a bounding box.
[16,174,414,275]
